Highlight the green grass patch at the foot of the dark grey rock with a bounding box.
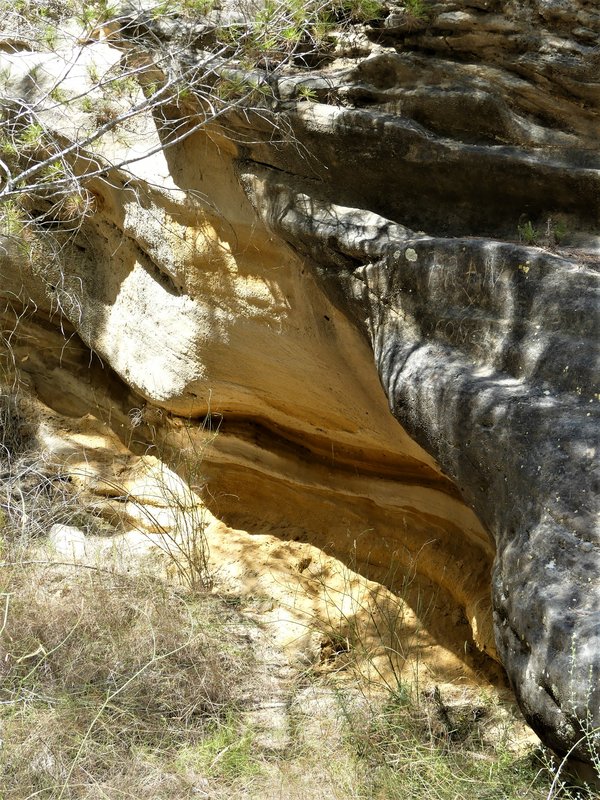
[332,691,596,800]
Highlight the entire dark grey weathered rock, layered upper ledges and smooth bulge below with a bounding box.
[240,0,600,761]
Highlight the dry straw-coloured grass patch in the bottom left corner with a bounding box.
[0,566,252,800]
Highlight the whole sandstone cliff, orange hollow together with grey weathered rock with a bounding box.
[0,0,600,760]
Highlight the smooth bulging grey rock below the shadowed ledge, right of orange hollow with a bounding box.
[365,240,600,752]
